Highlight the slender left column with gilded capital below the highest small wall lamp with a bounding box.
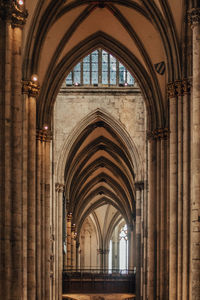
[22,81,39,299]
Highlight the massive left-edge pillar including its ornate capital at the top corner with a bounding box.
[0,0,27,300]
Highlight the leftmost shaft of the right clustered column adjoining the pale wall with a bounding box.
[147,139,156,300]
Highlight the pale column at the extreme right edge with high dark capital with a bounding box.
[188,7,200,300]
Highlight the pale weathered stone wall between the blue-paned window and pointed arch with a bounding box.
[53,88,146,176]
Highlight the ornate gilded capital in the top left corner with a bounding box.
[0,0,28,27]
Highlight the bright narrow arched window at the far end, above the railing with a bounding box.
[119,224,128,272]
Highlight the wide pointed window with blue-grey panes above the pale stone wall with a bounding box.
[66,49,135,86]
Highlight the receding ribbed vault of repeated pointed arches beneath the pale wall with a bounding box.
[64,117,135,232]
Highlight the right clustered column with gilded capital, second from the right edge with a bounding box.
[168,79,190,300]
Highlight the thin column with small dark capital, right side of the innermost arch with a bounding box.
[135,182,144,300]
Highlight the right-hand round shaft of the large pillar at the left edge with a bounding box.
[10,27,23,299]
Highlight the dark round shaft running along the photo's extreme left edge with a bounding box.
[0,20,13,299]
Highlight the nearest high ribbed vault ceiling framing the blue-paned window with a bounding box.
[23,0,193,128]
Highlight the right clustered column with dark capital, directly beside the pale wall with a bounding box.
[147,128,168,300]
